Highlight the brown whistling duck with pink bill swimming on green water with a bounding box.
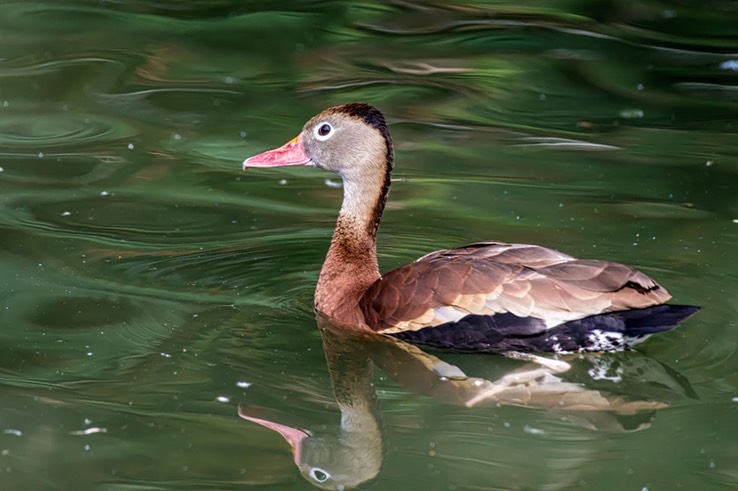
[243,103,699,353]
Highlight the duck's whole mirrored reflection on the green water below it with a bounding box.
[239,315,691,490]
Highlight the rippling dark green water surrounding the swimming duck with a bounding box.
[0,1,738,491]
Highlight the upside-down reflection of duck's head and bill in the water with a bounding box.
[239,407,382,491]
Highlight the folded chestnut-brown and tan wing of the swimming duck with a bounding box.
[360,242,671,333]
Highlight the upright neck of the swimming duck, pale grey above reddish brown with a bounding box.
[315,161,392,327]
